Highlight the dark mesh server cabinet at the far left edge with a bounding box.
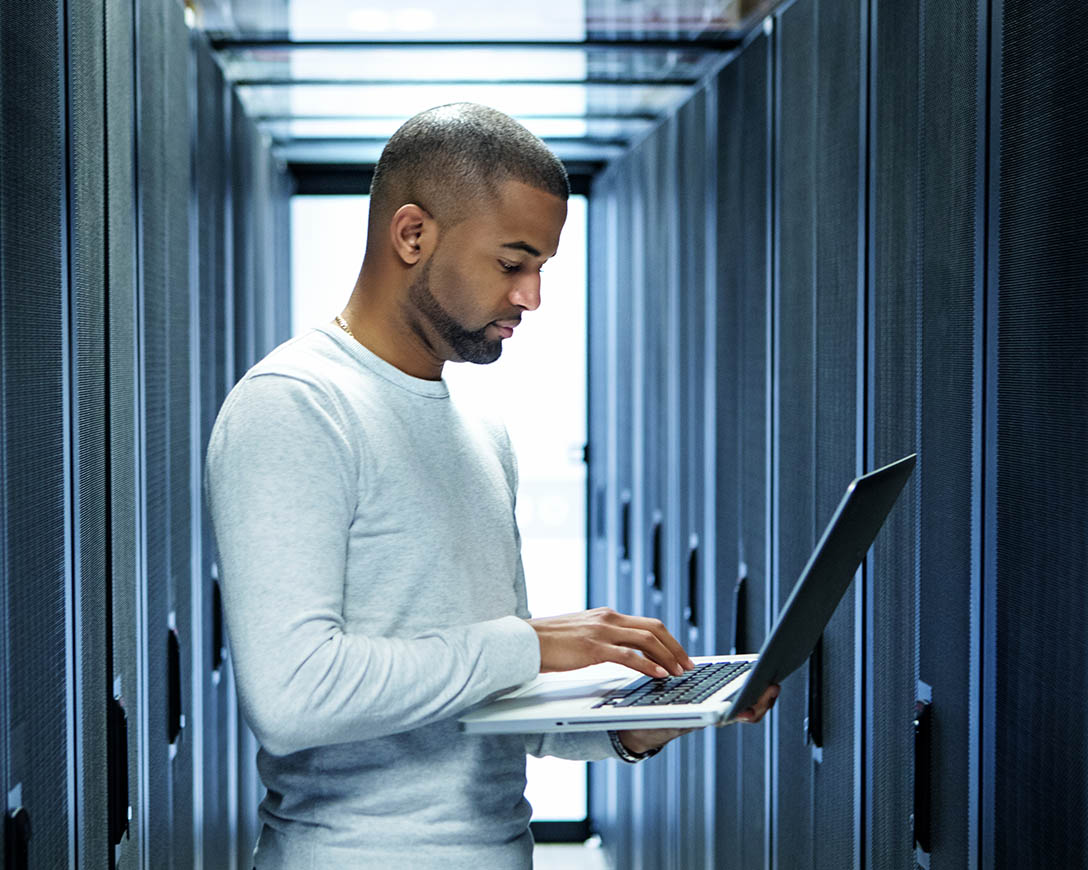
[0,2,73,867]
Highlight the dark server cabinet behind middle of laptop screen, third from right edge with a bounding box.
[772,0,865,868]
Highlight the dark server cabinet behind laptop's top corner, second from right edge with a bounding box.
[865,1,986,868]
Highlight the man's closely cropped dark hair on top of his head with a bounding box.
[370,102,570,229]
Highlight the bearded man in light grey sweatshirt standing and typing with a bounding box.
[208,104,777,870]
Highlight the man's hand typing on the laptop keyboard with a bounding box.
[529,607,695,678]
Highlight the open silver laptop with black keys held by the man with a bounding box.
[458,453,916,734]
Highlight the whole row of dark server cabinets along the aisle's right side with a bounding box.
[595,0,1088,868]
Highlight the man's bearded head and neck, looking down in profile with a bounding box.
[354,103,569,377]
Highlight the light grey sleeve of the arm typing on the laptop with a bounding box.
[207,375,540,755]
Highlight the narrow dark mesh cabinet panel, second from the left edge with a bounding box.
[67,0,110,867]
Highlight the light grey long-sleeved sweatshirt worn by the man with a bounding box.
[207,326,614,870]
